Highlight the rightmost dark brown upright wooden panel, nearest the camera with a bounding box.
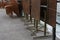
[47,0,57,27]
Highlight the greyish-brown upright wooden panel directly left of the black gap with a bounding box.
[31,0,41,20]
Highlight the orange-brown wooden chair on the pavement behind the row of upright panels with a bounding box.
[5,0,20,17]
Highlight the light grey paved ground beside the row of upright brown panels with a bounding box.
[0,9,58,40]
